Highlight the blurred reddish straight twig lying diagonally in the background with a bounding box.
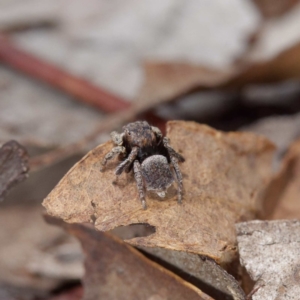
[0,34,130,113]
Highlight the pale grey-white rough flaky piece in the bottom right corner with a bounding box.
[236,220,300,300]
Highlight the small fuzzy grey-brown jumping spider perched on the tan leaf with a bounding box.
[101,121,184,209]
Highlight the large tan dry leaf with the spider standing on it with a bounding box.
[43,121,274,263]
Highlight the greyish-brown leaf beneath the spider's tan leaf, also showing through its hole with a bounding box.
[111,224,245,300]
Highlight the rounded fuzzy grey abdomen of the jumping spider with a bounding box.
[141,155,174,191]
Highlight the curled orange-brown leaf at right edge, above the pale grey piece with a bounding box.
[265,140,300,220]
